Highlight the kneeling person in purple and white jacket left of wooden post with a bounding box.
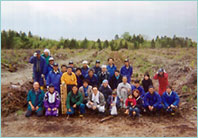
[44,84,60,116]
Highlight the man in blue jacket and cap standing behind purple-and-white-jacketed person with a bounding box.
[46,63,62,94]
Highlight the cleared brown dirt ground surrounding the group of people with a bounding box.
[1,49,197,137]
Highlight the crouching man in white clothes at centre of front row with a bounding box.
[86,86,105,113]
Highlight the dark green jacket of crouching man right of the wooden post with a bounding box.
[66,91,83,109]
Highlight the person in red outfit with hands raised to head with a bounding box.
[153,68,168,96]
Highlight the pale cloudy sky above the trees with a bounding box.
[1,1,197,41]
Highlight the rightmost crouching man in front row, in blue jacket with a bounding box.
[162,86,179,115]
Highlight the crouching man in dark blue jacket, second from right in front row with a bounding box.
[144,86,162,114]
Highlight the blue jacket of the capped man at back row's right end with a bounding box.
[120,65,133,83]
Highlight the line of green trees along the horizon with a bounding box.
[1,30,197,51]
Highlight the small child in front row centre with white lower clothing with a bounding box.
[107,91,120,116]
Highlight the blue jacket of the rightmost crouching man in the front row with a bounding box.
[162,91,179,108]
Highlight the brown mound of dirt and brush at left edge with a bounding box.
[1,81,32,116]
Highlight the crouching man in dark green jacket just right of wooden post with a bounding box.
[66,85,85,117]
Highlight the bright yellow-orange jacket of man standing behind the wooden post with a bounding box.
[61,72,77,85]
